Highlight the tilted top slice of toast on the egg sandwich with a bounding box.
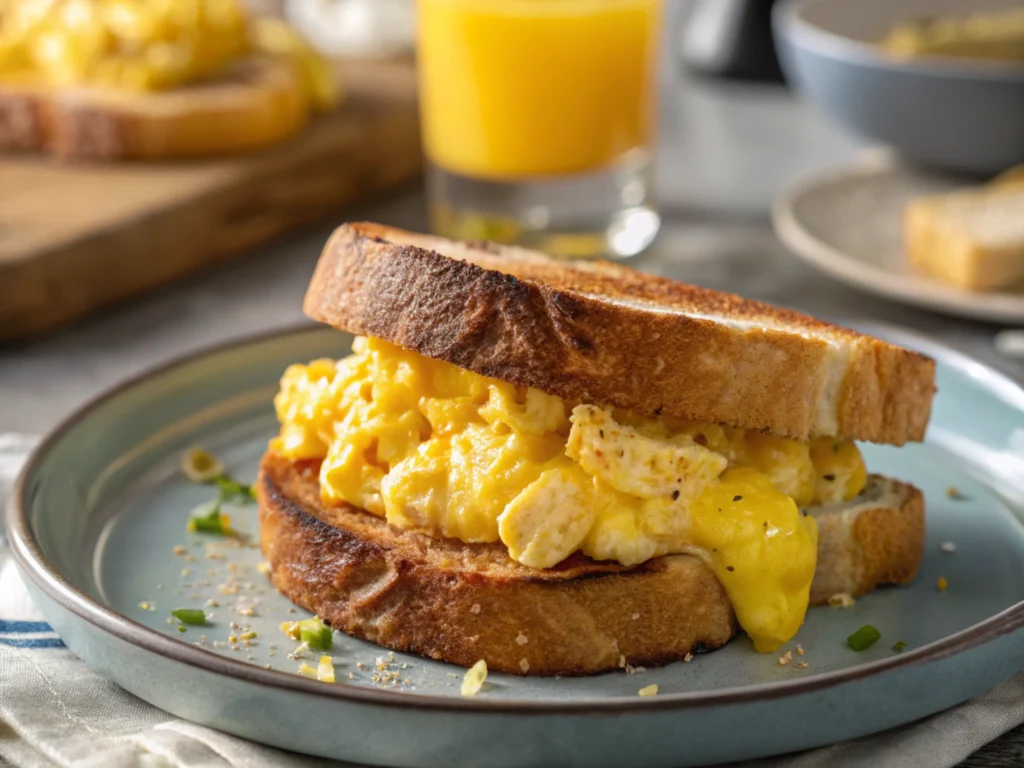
[304,223,935,445]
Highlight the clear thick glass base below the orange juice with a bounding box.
[427,153,662,258]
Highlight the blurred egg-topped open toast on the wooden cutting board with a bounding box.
[0,0,338,160]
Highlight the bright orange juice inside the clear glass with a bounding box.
[419,0,662,180]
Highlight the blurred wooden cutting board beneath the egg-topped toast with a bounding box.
[0,61,423,341]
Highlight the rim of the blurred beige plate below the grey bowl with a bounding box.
[771,156,1024,323]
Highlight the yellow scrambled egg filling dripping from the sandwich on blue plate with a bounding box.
[270,338,866,651]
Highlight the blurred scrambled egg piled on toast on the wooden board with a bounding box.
[0,0,335,108]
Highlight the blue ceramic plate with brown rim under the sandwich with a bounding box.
[8,321,1024,768]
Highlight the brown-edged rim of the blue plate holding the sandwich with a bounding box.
[5,322,1024,716]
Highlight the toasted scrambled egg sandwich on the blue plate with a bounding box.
[257,224,934,675]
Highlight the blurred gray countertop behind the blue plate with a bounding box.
[0,40,1024,766]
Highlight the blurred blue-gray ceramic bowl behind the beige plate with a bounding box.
[774,0,1024,174]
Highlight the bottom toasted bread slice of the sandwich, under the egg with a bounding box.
[257,453,924,675]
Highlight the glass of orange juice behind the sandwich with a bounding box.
[418,0,663,257]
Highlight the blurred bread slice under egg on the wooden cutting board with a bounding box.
[0,56,310,160]
